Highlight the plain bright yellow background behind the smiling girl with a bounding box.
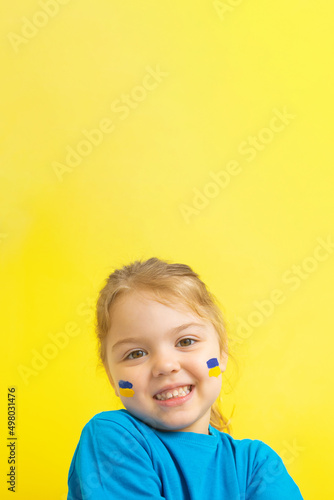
[0,0,334,500]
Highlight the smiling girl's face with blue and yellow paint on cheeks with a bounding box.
[106,292,227,434]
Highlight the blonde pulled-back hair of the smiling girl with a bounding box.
[96,257,233,434]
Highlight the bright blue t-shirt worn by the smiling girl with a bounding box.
[67,410,302,500]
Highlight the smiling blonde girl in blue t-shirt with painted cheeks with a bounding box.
[68,258,302,500]
